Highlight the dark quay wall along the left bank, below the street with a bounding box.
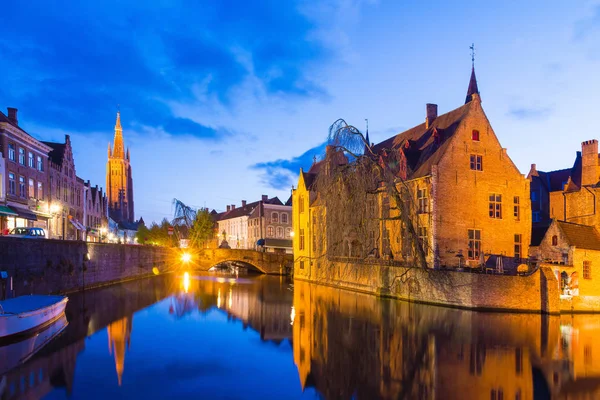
[0,237,173,296]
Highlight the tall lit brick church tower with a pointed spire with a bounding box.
[106,112,135,223]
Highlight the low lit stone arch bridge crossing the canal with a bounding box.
[192,249,294,275]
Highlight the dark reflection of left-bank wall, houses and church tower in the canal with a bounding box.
[0,279,169,400]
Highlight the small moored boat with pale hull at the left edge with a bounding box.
[0,295,69,341]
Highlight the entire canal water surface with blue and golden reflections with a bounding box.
[0,274,600,400]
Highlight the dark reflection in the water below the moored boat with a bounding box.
[0,314,68,376]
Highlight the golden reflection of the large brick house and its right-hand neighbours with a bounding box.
[293,281,600,400]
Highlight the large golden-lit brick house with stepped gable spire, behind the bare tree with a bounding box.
[294,69,531,267]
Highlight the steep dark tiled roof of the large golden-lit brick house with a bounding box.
[373,102,473,179]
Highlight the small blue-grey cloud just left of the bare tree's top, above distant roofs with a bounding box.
[250,143,326,190]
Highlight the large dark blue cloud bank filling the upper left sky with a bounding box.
[0,0,330,140]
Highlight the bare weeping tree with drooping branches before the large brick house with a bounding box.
[314,119,429,268]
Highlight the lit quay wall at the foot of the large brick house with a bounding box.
[294,260,560,314]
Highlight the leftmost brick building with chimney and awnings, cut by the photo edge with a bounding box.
[0,108,52,233]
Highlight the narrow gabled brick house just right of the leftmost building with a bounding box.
[44,135,86,240]
